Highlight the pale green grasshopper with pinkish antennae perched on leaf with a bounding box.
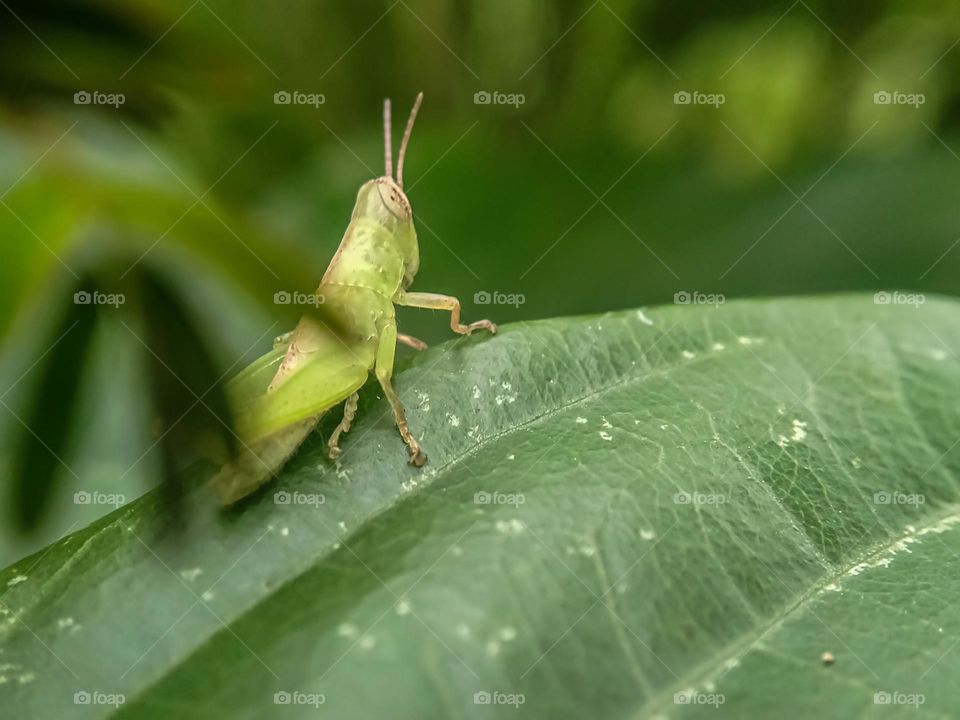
[213,93,497,504]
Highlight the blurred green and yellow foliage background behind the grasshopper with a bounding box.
[0,0,960,560]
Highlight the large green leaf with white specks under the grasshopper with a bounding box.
[0,296,960,718]
